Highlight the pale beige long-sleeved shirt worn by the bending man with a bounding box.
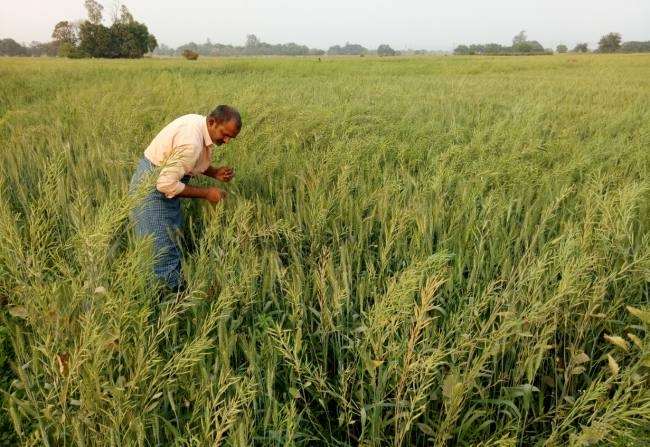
[144,114,214,199]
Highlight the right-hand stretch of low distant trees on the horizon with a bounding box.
[454,31,650,55]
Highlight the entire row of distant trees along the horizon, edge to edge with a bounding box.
[0,18,650,59]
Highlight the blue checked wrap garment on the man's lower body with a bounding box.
[129,157,190,291]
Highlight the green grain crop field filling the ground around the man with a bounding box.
[0,55,650,446]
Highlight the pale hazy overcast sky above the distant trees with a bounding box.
[0,0,650,50]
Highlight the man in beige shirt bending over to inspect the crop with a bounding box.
[130,105,242,291]
